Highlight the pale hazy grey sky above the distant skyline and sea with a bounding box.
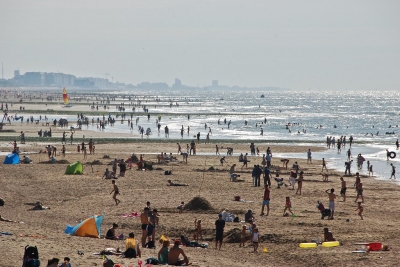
[0,0,400,91]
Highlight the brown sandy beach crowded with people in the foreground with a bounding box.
[0,91,400,267]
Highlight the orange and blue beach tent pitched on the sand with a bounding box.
[65,214,104,238]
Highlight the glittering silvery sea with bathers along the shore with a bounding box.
[9,89,400,184]
